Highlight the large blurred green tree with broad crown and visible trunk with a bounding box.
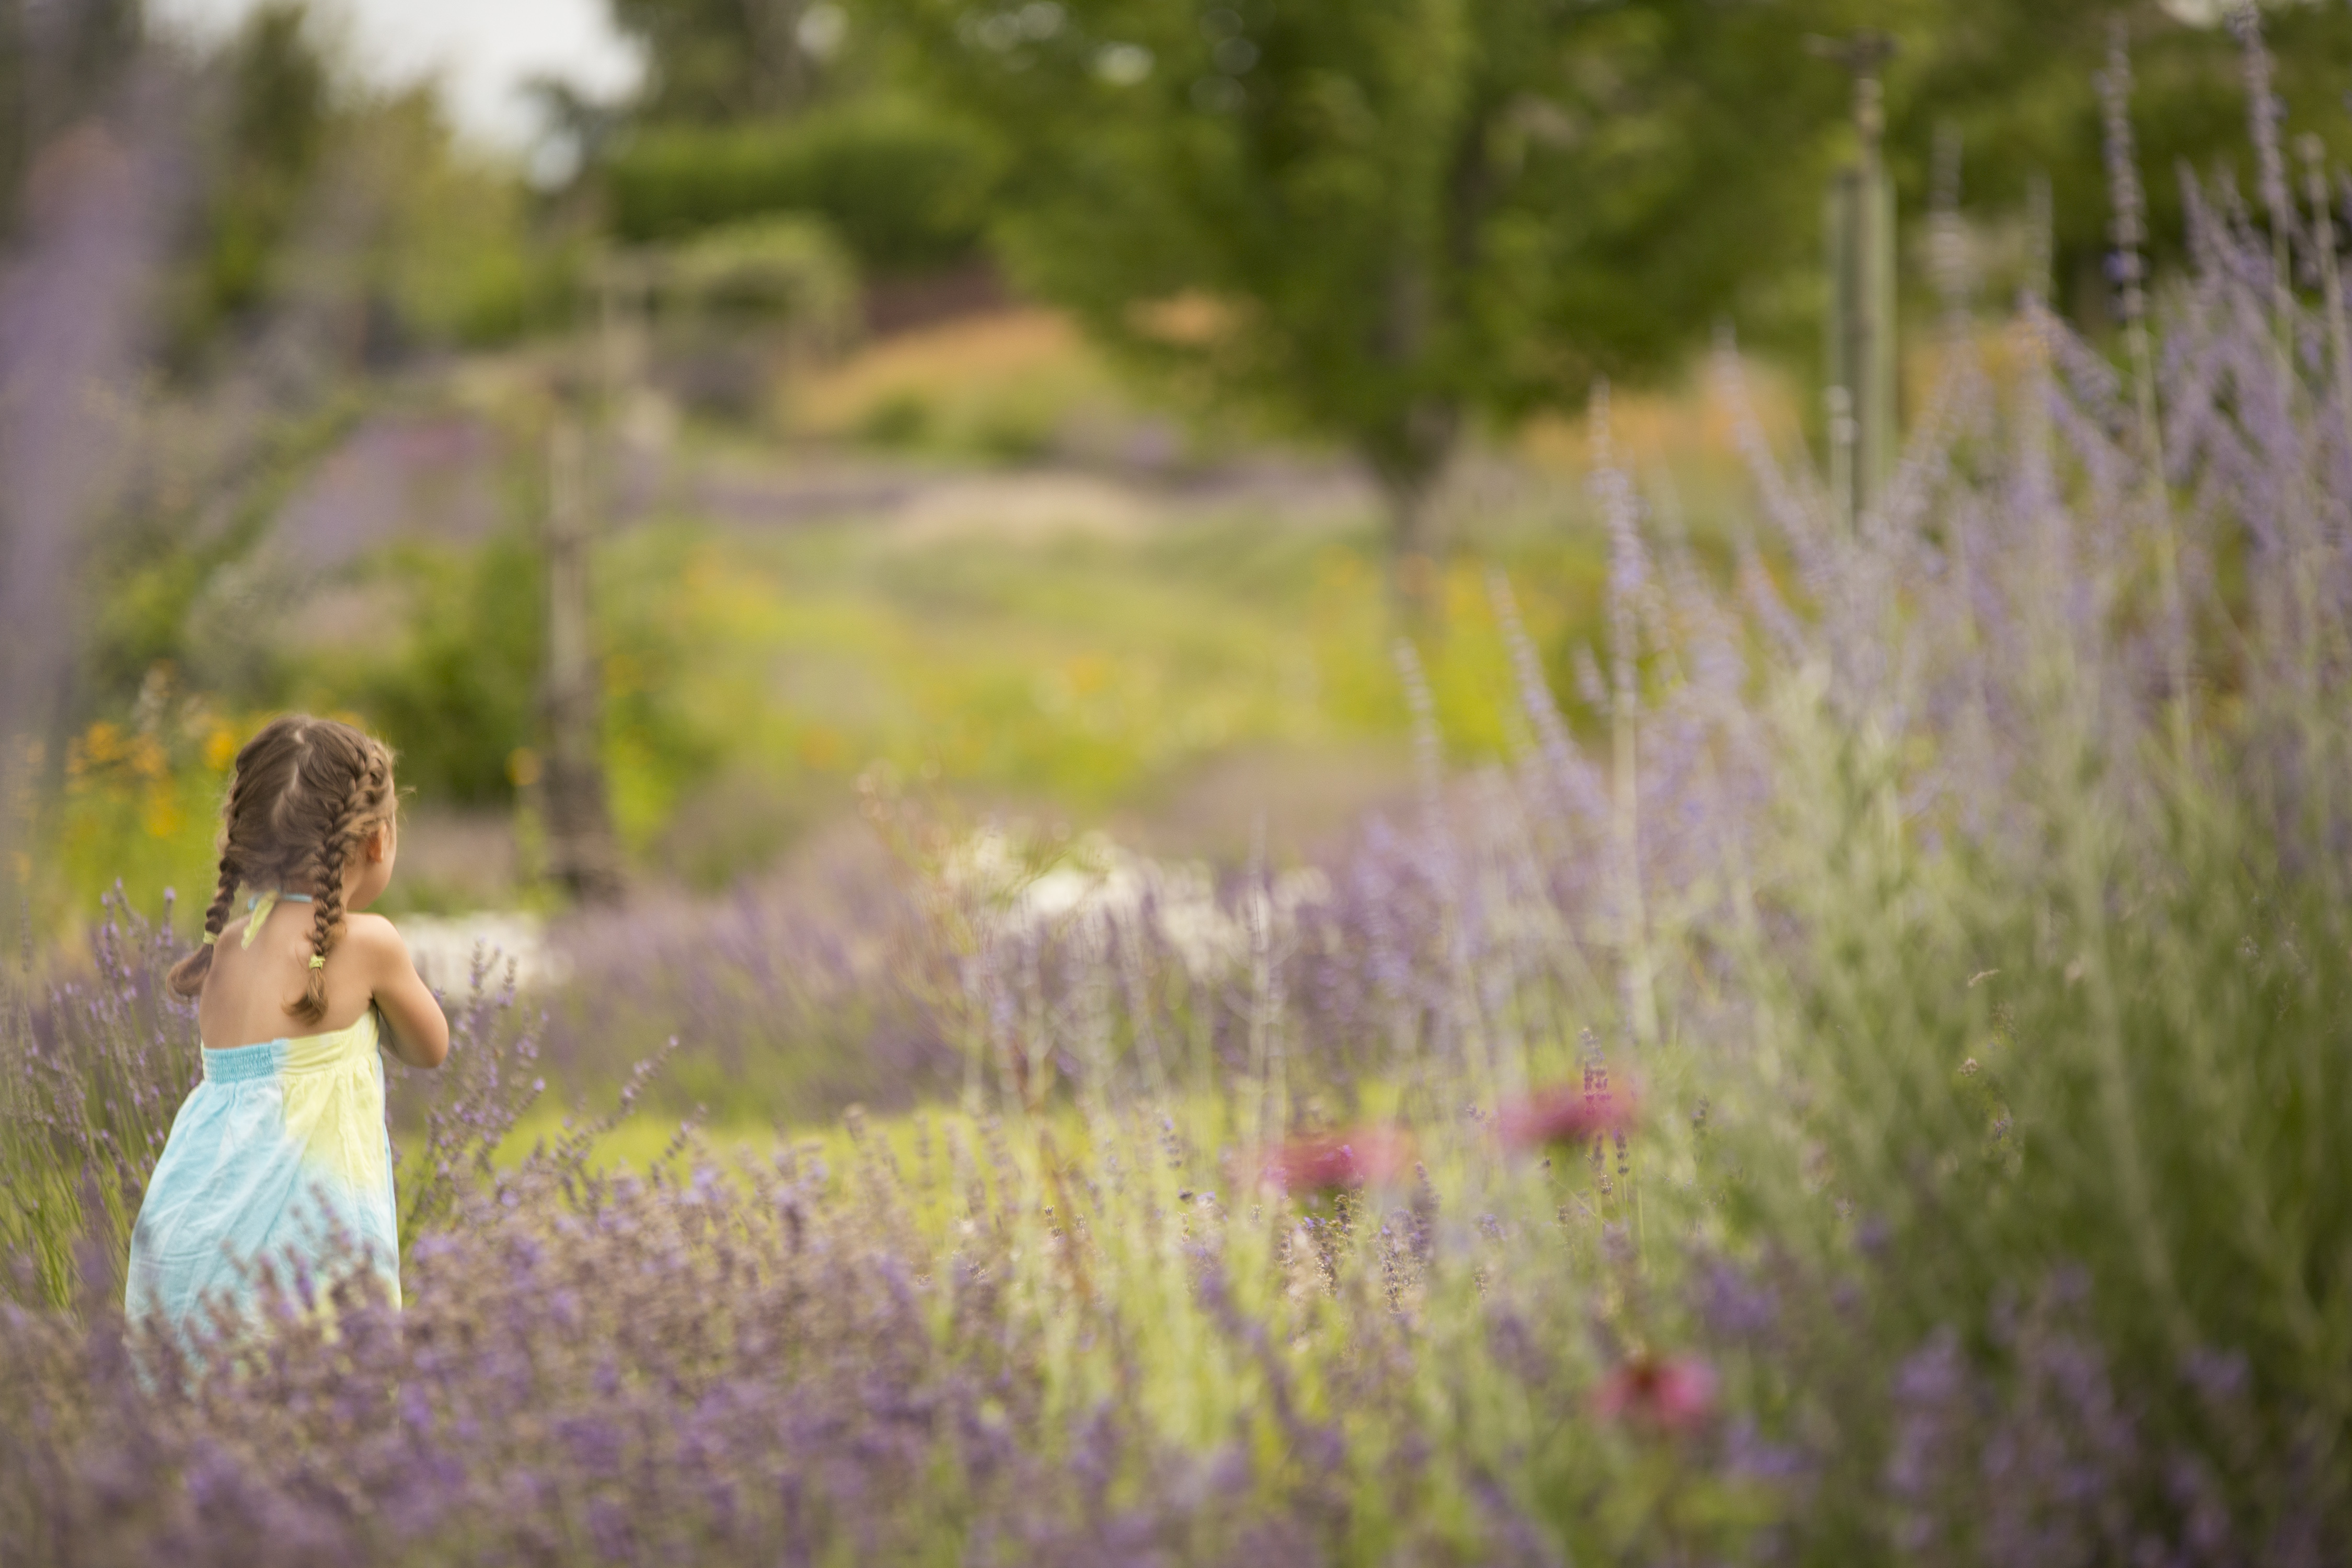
[880,0,1882,602]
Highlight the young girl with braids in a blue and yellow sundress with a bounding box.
[125,714,449,1328]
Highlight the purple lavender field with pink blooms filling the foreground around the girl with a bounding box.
[0,9,2352,1568]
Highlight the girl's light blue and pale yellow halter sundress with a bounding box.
[125,893,400,1331]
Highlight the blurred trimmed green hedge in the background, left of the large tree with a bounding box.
[602,99,990,273]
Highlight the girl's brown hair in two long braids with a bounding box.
[172,714,398,1028]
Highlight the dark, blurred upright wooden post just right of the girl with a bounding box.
[541,419,621,903]
